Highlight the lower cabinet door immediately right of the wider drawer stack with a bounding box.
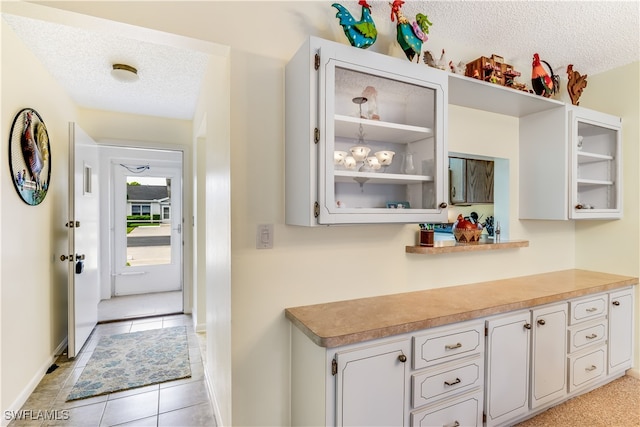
[485,310,531,427]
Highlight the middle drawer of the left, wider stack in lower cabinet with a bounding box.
[411,357,483,408]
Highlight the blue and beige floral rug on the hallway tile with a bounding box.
[67,326,191,401]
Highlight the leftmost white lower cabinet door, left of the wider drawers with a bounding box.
[334,339,411,426]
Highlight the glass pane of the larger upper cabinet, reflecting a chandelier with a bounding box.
[327,66,436,209]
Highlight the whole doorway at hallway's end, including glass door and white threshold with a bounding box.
[98,146,184,322]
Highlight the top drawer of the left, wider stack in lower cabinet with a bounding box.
[413,322,484,369]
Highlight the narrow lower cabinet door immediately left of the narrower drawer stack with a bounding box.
[531,303,567,409]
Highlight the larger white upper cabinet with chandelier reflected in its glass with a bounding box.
[285,37,448,226]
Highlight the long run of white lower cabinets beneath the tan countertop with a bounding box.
[291,287,635,427]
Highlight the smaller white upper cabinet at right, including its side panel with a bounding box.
[520,106,622,220]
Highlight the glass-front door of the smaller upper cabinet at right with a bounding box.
[569,107,622,219]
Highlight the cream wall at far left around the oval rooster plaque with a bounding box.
[0,15,77,423]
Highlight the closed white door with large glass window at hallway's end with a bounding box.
[112,158,183,296]
